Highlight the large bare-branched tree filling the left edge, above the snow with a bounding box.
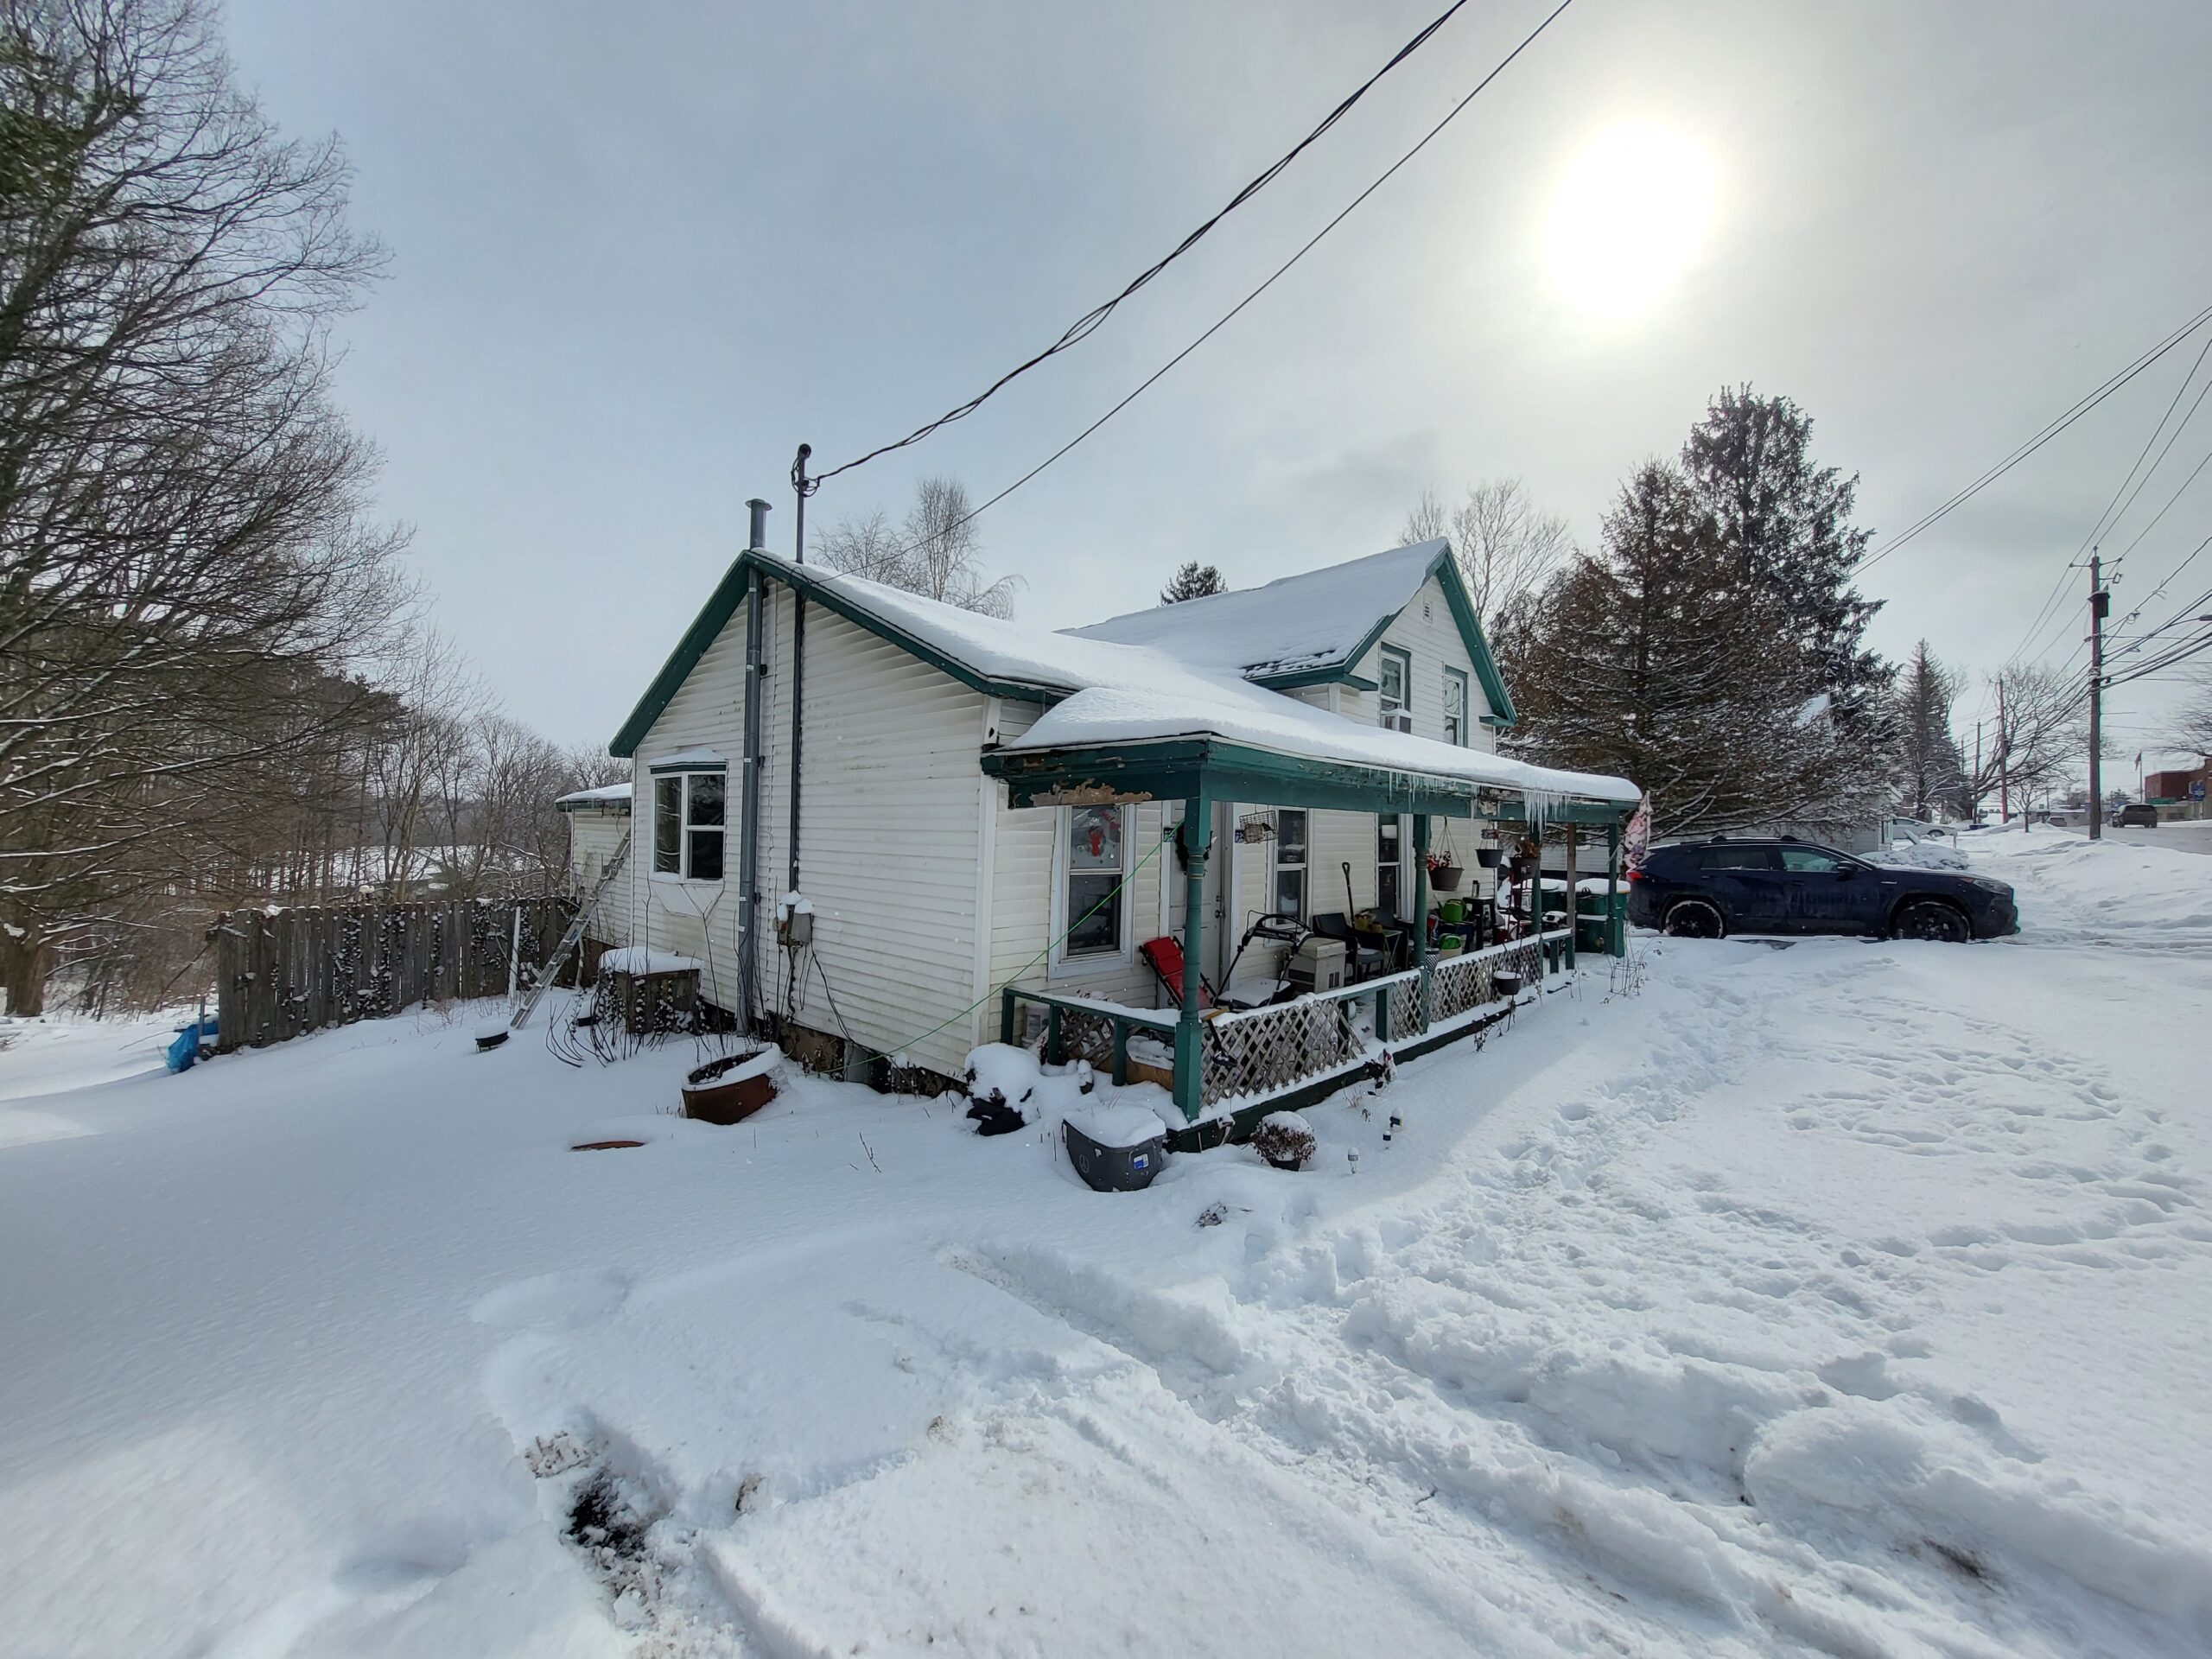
[0,0,403,1011]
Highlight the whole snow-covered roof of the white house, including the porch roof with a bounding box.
[615,542,1637,803]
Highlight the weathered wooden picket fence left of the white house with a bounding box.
[214,896,575,1053]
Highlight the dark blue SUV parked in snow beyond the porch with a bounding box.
[1628,836,2019,940]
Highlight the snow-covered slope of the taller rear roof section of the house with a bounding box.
[1068,540,1451,679]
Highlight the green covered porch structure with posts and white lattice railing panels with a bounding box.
[982,734,1635,1135]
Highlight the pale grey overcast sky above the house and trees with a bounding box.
[211,0,2212,781]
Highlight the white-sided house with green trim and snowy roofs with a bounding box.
[564,506,1637,1115]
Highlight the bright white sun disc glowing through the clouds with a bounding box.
[1546,124,1714,321]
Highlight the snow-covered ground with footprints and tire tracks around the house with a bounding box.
[0,834,2212,1659]
